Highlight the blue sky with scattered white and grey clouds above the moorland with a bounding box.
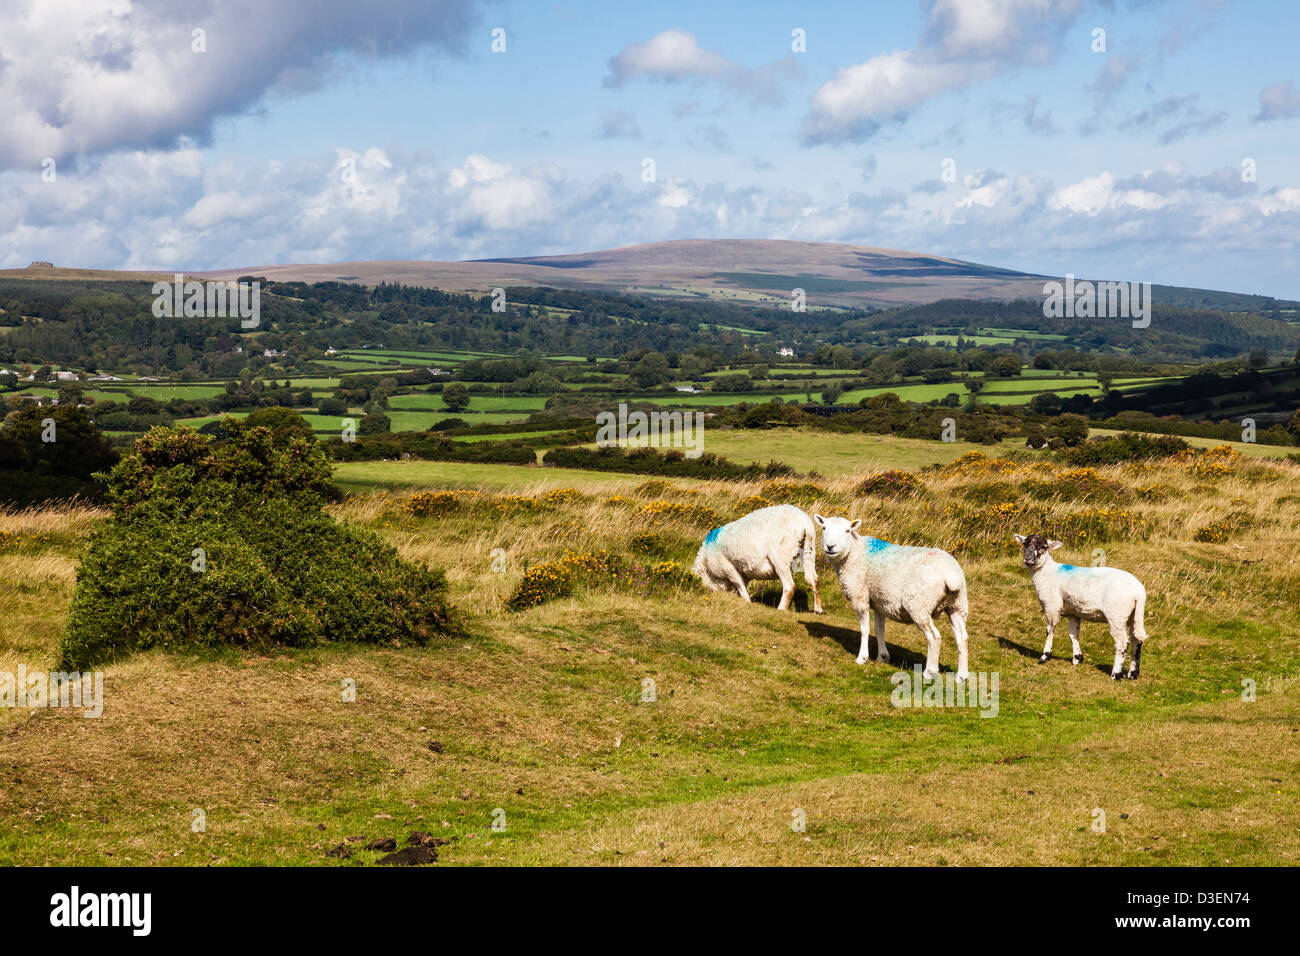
[0,0,1300,298]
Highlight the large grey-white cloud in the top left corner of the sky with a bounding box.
[0,0,476,169]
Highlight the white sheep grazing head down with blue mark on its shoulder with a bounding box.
[690,505,822,614]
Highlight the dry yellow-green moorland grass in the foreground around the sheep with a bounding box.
[0,434,1300,865]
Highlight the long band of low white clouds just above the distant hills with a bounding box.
[0,148,1300,295]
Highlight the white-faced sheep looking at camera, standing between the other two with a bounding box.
[813,515,970,683]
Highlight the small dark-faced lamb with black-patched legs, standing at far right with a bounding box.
[1014,535,1147,680]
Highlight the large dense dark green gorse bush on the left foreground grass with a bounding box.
[60,420,458,669]
